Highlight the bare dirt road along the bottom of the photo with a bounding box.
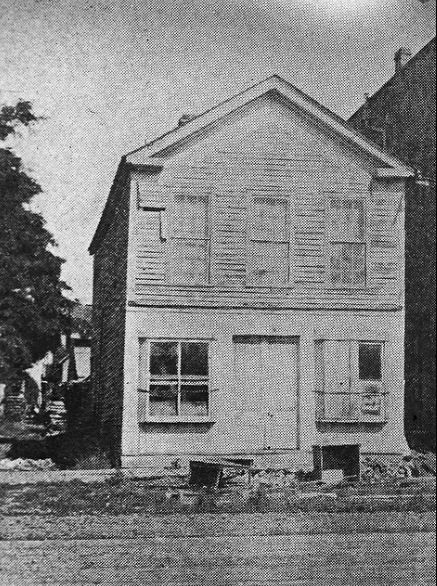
[0,533,435,586]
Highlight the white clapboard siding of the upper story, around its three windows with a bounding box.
[135,102,399,309]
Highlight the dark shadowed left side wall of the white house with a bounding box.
[92,173,130,465]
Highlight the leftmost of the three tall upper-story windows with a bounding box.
[172,193,210,285]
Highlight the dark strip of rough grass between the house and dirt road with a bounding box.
[0,472,436,516]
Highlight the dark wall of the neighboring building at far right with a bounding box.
[349,39,436,449]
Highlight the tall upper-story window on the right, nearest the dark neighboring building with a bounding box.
[329,197,366,287]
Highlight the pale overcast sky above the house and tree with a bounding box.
[0,0,435,302]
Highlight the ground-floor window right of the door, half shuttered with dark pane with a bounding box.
[316,340,386,422]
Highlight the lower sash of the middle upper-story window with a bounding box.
[251,242,289,287]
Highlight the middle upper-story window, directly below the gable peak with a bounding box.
[248,196,290,287]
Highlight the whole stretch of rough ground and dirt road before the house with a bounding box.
[0,478,436,586]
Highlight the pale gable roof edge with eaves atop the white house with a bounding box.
[89,75,414,254]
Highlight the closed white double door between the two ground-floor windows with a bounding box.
[233,336,299,450]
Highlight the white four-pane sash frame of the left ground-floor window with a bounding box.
[140,339,210,418]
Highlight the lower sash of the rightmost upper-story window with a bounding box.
[331,242,366,286]
